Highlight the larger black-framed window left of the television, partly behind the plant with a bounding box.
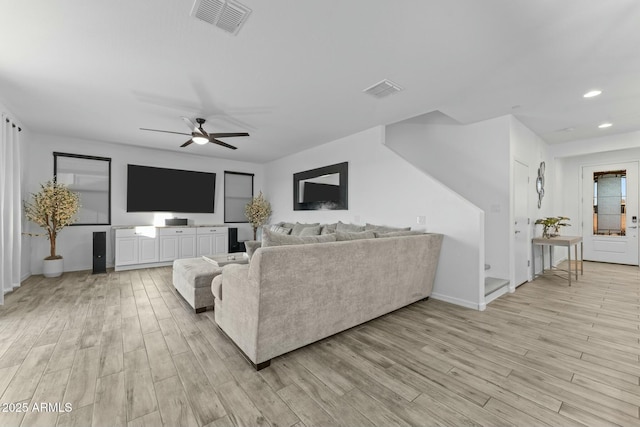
[53,153,111,225]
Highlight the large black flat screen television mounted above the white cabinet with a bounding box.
[127,165,216,213]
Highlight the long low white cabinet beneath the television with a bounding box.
[113,225,229,271]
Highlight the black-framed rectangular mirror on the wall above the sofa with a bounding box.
[293,162,349,211]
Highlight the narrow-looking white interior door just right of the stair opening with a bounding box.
[513,161,531,286]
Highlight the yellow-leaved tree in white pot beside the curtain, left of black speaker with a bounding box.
[24,180,80,277]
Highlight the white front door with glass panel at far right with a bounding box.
[582,162,638,265]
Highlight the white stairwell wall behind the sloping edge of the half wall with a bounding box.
[387,116,511,279]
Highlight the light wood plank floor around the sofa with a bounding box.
[0,263,640,426]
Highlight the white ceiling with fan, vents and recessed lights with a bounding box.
[0,0,640,162]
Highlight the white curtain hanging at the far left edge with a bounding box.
[0,114,22,304]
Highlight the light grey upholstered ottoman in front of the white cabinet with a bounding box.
[173,258,222,313]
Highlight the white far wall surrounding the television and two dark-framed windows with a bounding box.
[26,134,264,274]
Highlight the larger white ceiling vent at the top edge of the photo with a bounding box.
[191,0,251,35]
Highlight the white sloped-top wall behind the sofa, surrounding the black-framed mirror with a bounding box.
[265,127,484,309]
